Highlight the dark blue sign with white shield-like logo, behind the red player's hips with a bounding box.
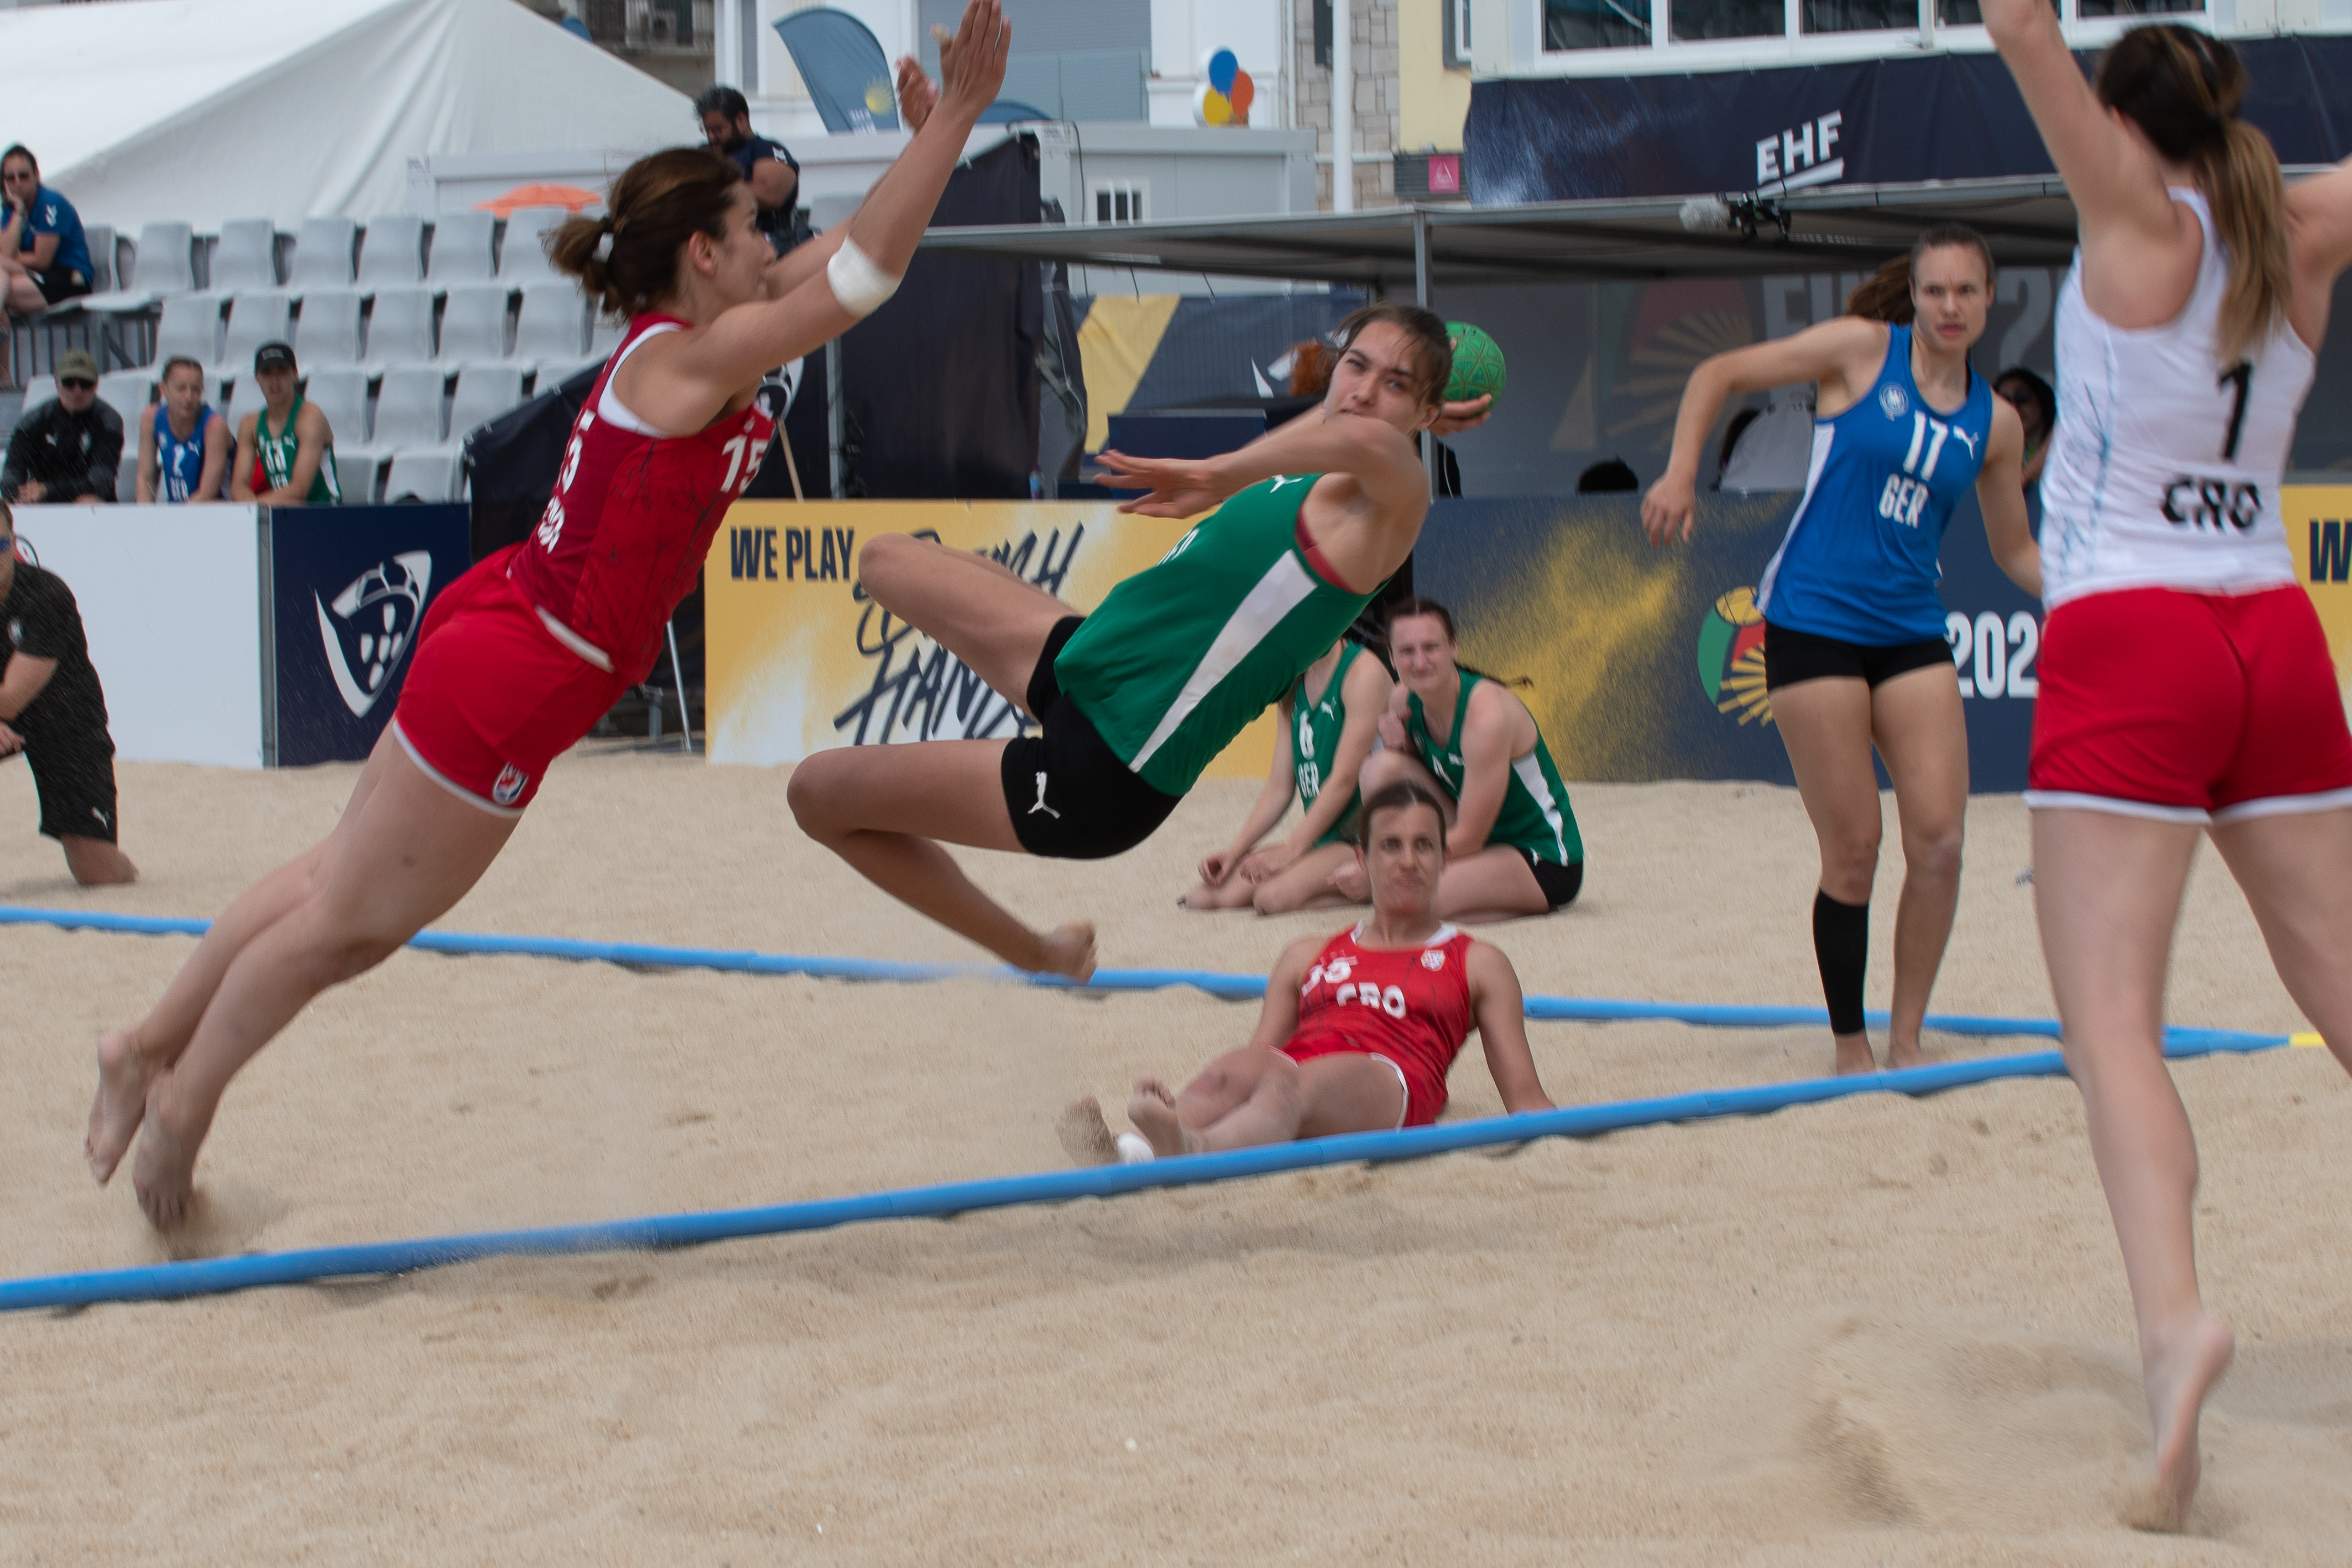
[268,506,473,766]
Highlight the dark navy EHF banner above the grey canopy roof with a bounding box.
[1463,35,2352,207]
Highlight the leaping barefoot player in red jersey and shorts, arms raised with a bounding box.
[85,0,1011,1227]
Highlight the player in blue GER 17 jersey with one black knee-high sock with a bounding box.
[1642,223,2042,1072]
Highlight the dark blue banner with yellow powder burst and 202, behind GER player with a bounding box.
[1414,494,2042,792]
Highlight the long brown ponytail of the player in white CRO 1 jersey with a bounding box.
[2095,23,2293,365]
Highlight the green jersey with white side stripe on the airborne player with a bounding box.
[1054,475,1378,795]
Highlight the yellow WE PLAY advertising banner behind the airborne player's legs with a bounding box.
[703,501,1275,776]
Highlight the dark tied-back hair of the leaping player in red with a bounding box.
[546,146,743,315]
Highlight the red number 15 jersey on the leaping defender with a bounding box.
[508,315,776,682]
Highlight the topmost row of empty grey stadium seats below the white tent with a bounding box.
[59,207,572,315]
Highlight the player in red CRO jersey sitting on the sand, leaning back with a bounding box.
[1058,783,1552,1164]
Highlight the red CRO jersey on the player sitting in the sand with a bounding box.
[1282,926,1470,1126]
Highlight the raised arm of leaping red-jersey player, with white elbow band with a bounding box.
[621,0,1011,430]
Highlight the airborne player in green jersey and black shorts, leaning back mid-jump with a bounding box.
[788,303,1484,980]
